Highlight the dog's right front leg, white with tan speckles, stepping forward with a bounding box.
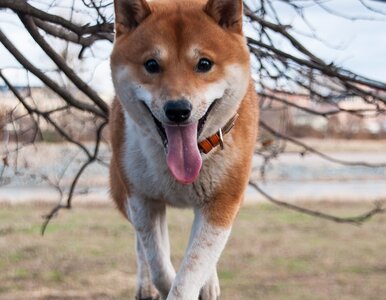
[167,208,231,300]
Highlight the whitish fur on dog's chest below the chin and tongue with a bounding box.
[122,112,236,207]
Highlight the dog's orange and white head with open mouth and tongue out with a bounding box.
[111,0,250,183]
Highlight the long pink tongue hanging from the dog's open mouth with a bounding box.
[164,122,202,184]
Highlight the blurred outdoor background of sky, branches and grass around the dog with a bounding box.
[0,0,386,299]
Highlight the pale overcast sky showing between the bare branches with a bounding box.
[0,0,386,96]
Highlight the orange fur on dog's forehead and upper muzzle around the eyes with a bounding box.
[111,1,249,105]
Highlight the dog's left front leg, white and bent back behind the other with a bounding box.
[128,197,175,299]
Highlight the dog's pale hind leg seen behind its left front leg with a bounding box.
[135,234,159,300]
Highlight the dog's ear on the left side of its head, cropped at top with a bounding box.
[114,0,151,35]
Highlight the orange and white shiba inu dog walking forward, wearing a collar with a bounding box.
[110,0,258,300]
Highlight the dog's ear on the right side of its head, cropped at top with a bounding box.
[204,0,243,33]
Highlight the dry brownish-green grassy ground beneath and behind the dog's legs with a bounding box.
[0,203,386,300]
